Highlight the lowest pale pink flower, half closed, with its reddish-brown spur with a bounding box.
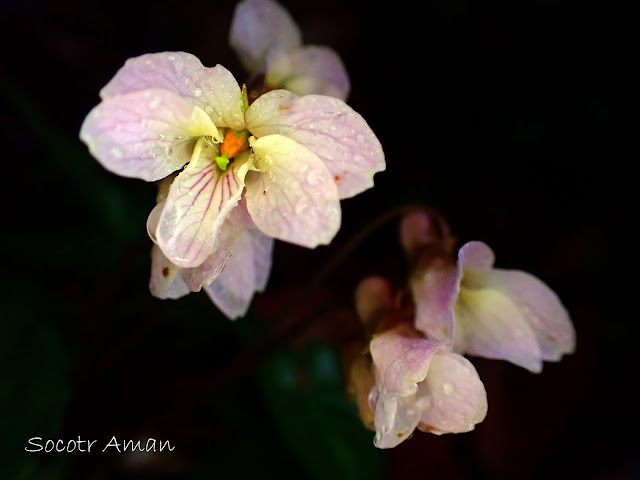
[356,278,487,448]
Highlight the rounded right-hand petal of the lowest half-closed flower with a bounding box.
[417,353,487,434]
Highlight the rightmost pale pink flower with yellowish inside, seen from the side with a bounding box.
[402,213,575,373]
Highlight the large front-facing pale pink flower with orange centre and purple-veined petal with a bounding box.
[80,52,385,316]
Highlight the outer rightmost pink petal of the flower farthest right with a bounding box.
[492,269,576,361]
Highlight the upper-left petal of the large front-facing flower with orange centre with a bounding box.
[100,52,244,130]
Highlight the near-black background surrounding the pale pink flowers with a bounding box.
[0,0,640,479]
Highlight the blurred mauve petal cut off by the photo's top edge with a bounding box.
[229,0,302,73]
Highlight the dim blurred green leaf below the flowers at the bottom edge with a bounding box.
[260,345,384,480]
